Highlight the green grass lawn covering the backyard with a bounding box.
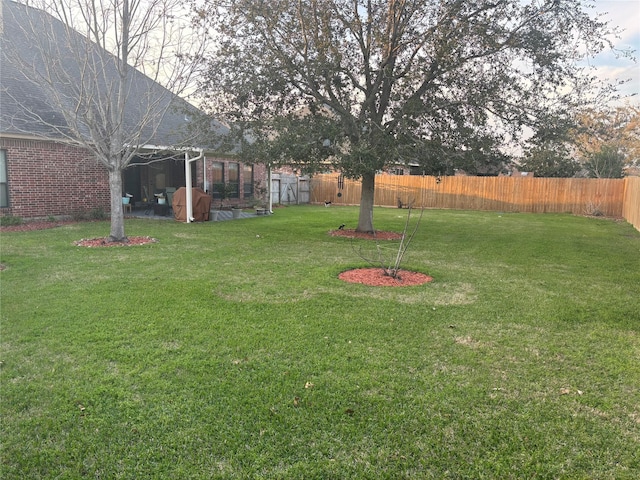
[0,206,640,479]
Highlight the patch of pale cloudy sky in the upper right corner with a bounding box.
[590,0,640,105]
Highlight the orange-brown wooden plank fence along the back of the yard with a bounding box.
[310,173,640,228]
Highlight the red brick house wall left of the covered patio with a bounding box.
[0,138,110,218]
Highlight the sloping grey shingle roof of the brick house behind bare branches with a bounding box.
[0,0,228,147]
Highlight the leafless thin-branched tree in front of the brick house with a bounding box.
[2,0,206,241]
